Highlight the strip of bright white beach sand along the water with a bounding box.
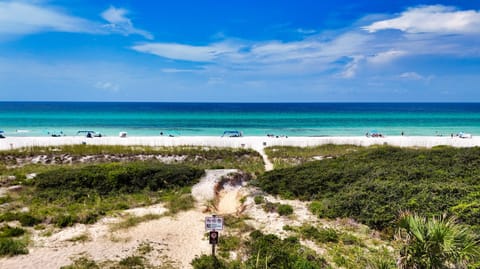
[0,136,480,150]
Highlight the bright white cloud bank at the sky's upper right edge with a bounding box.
[363,5,480,33]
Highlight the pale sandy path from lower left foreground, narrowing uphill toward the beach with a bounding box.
[0,169,242,269]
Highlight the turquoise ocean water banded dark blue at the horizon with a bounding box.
[0,102,480,136]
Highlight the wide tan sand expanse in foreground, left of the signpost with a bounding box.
[0,210,210,269]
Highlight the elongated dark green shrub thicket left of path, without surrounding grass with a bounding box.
[35,162,204,197]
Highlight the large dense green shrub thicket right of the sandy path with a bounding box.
[257,146,480,230]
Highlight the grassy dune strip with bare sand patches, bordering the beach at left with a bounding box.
[0,145,264,174]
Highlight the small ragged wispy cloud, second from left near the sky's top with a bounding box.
[101,6,153,39]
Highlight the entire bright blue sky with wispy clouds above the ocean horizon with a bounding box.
[0,0,480,102]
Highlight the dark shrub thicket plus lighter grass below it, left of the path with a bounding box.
[0,162,204,227]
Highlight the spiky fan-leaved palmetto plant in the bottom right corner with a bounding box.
[397,212,480,269]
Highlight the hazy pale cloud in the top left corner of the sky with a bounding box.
[0,2,98,35]
